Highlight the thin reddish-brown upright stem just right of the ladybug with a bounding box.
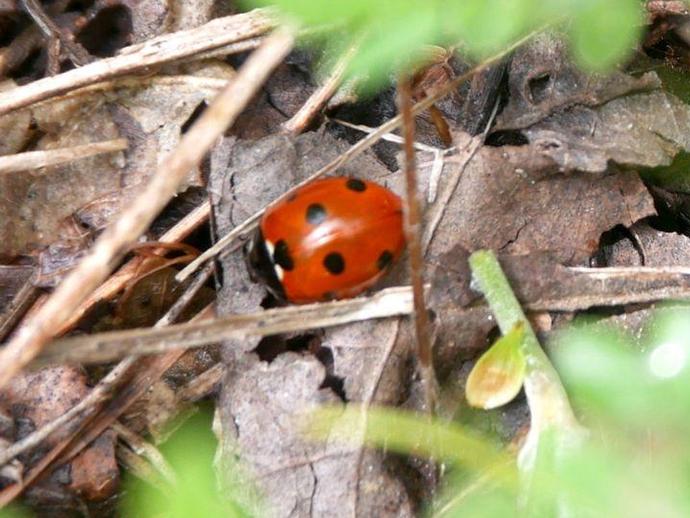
[398,77,436,414]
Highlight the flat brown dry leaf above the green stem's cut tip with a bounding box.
[430,146,655,264]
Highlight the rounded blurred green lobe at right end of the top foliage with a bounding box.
[570,0,643,71]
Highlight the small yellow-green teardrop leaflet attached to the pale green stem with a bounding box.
[465,322,526,409]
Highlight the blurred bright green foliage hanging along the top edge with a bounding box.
[244,0,643,91]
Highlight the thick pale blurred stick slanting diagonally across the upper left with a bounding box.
[0,30,293,387]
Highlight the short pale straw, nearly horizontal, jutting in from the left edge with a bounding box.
[0,138,127,174]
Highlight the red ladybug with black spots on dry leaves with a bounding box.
[247,177,405,304]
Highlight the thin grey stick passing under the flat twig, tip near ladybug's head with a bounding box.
[0,268,212,467]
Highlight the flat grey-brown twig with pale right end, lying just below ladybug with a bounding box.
[37,286,412,365]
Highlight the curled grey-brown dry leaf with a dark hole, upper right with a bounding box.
[496,36,690,173]
